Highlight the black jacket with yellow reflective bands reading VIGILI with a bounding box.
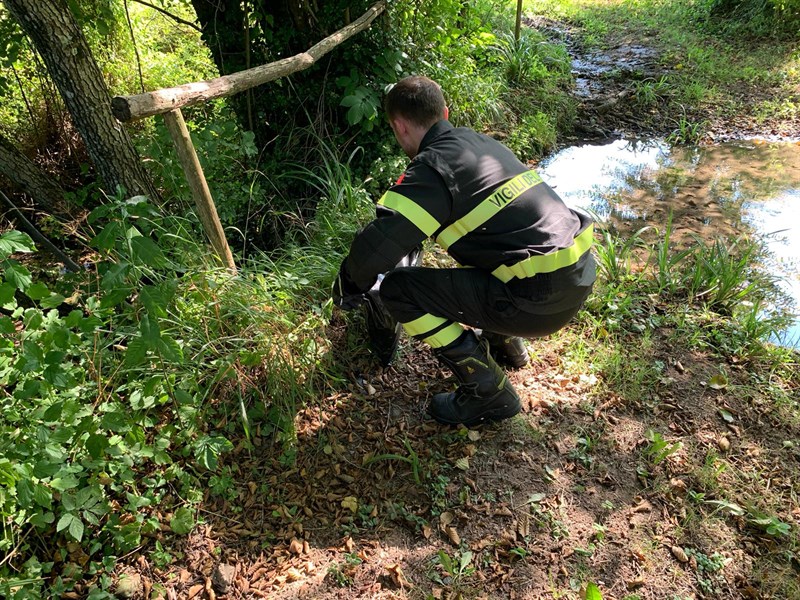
[345,120,595,308]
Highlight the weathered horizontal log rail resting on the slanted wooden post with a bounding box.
[111,0,386,122]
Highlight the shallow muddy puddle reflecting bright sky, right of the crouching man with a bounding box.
[539,140,800,347]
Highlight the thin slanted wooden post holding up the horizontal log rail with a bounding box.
[164,108,236,273]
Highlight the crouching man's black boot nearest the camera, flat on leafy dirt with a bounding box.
[428,331,521,427]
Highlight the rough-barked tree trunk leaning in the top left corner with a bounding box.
[2,0,158,198]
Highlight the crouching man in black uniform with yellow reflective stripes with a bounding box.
[333,76,595,426]
